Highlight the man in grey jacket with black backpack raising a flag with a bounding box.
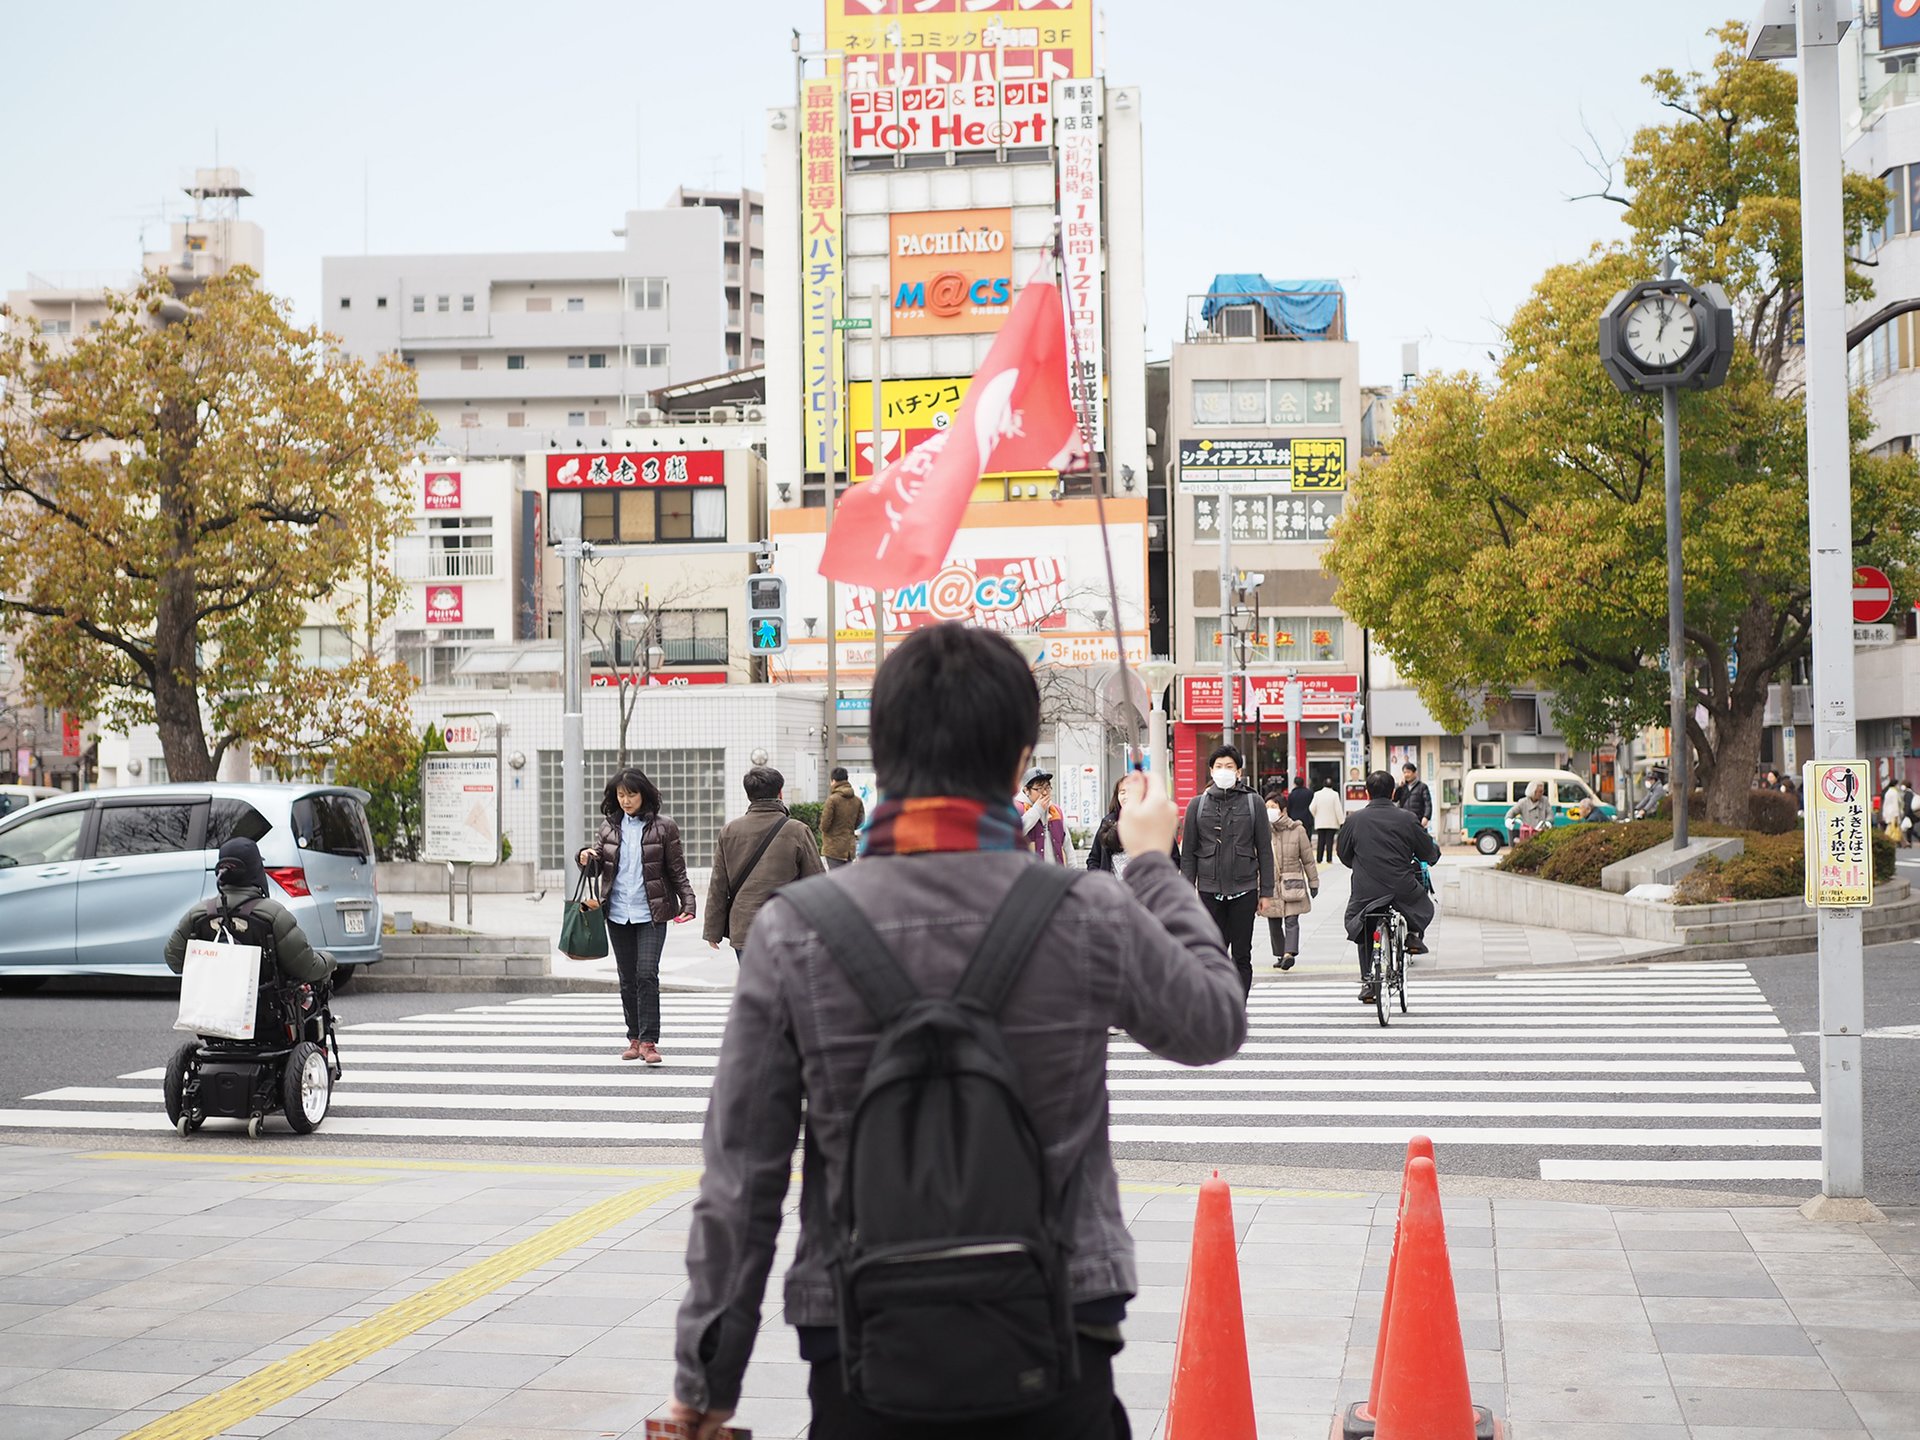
[672,622,1246,1440]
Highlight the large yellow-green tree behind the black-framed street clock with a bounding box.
[1327,25,1920,826]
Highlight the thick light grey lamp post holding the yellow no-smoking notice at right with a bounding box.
[1751,0,1880,1219]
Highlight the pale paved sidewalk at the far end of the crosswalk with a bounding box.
[380,854,1667,989]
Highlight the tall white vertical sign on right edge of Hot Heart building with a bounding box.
[1054,81,1106,451]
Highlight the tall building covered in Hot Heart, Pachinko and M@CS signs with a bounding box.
[766,0,1148,808]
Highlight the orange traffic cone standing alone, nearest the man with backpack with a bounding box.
[1165,1171,1254,1440]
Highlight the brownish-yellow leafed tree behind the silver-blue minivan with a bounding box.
[0,269,432,780]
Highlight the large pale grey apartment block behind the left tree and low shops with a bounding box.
[321,190,764,457]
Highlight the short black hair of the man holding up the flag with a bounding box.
[868,620,1041,804]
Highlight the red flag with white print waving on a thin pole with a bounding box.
[820,280,1085,589]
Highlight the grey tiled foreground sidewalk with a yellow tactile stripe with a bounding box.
[0,1140,1920,1440]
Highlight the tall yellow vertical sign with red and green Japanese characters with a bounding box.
[801,81,845,474]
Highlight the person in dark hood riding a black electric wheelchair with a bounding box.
[165,839,340,1139]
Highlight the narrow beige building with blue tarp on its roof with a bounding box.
[1164,275,1367,799]
